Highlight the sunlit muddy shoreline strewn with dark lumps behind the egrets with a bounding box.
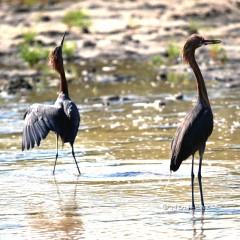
[0,0,240,94]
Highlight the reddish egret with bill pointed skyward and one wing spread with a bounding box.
[22,33,80,174]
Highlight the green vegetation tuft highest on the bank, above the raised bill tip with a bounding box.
[63,9,91,29]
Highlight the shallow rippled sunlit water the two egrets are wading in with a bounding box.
[0,63,240,239]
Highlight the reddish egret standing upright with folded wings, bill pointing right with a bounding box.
[170,34,221,209]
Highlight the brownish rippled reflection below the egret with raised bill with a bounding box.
[28,178,84,239]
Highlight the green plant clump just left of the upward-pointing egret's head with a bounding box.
[20,44,48,66]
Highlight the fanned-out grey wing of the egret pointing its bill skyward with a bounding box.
[22,104,64,150]
